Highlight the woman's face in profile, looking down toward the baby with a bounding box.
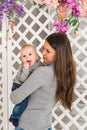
[42,41,56,65]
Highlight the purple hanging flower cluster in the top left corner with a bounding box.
[0,0,24,30]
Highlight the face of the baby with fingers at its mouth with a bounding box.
[21,46,38,66]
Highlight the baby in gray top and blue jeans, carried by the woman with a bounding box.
[9,44,42,127]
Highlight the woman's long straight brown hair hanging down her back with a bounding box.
[46,33,76,110]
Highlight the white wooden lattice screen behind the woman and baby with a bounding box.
[0,0,87,130]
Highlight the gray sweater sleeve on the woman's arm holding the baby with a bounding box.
[10,67,49,104]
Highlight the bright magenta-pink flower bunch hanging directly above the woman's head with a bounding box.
[54,20,68,33]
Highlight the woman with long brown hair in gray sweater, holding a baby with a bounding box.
[11,33,76,130]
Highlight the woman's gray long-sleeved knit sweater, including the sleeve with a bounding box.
[10,64,57,130]
